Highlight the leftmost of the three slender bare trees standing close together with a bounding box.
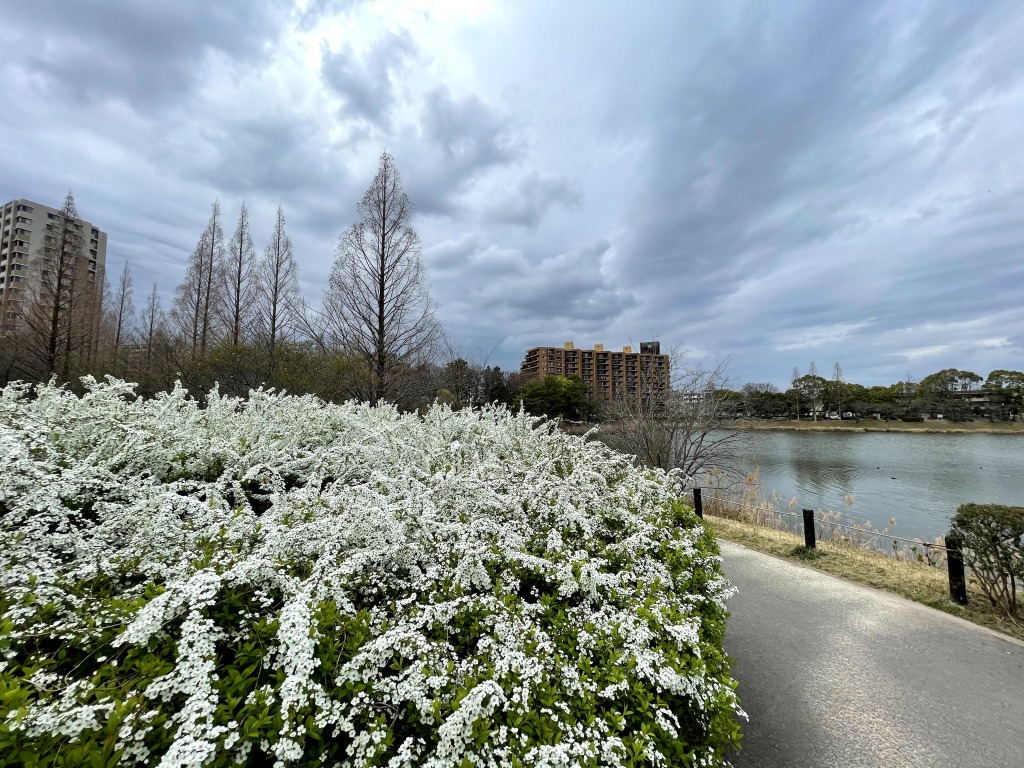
[171,201,224,357]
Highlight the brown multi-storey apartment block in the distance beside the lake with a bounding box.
[519,341,670,399]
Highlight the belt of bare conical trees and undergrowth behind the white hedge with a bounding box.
[0,153,517,409]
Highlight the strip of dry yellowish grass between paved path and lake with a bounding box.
[705,514,1024,640]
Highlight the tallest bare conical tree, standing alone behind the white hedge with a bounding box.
[319,147,442,404]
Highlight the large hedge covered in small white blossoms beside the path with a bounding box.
[0,380,740,768]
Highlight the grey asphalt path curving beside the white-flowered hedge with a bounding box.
[719,542,1024,768]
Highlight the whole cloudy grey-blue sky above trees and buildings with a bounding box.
[0,0,1024,387]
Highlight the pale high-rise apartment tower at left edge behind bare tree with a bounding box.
[0,200,106,330]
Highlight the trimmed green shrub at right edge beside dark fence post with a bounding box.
[949,504,1024,615]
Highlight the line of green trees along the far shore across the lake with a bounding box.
[726,362,1024,421]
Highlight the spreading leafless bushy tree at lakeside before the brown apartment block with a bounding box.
[601,349,742,478]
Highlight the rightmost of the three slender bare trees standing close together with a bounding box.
[255,206,302,367]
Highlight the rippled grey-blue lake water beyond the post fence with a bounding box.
[720,431,1024,541]
